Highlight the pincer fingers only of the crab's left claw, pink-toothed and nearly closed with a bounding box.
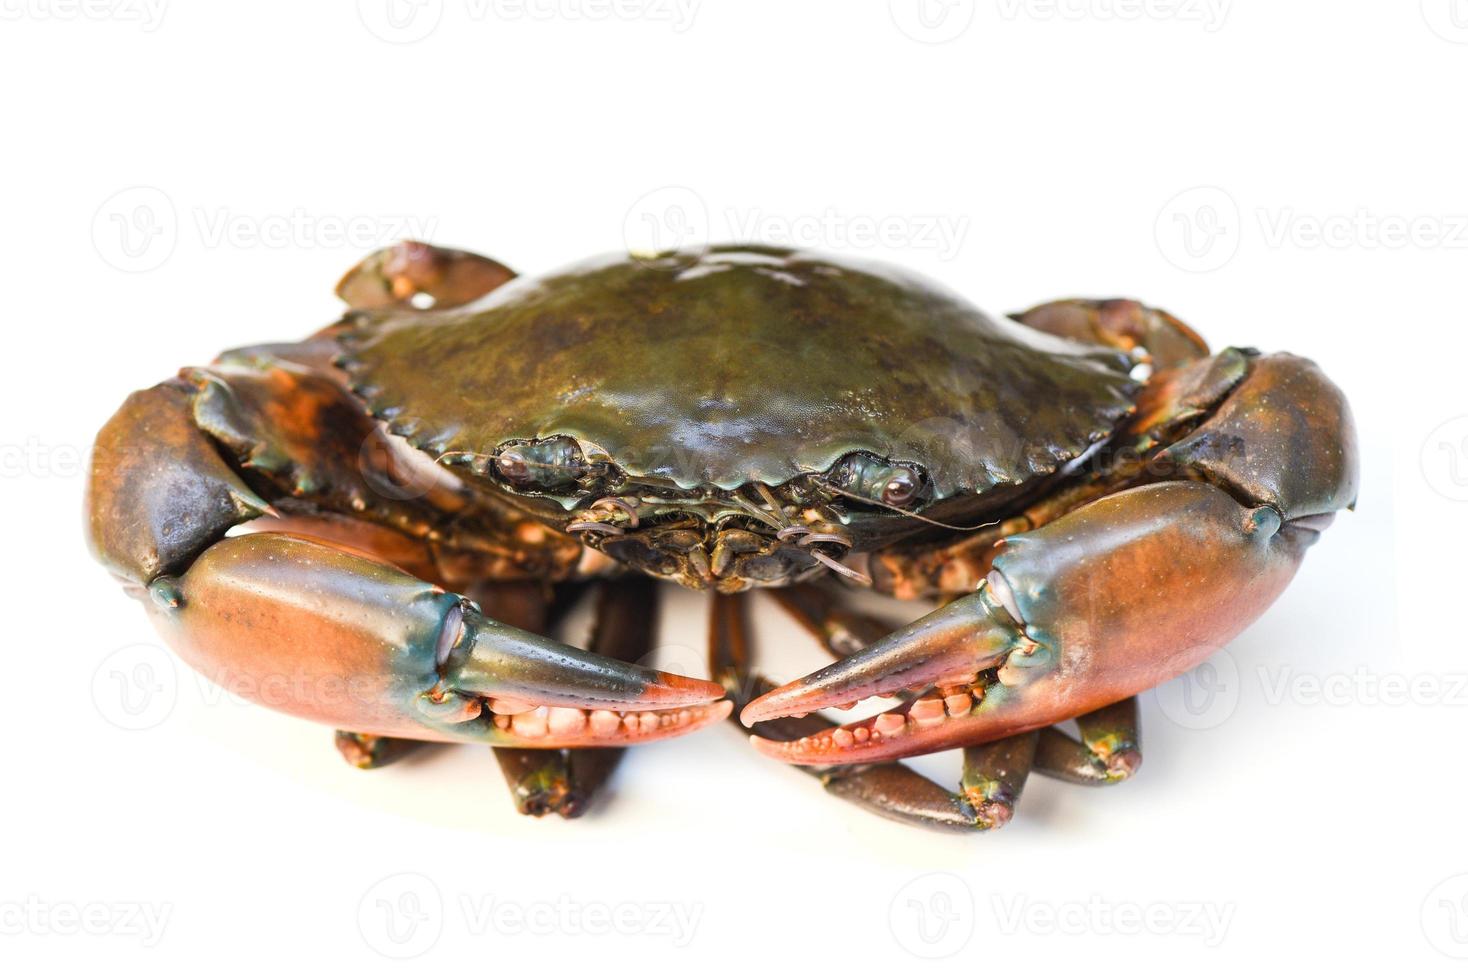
[431,603,733,748]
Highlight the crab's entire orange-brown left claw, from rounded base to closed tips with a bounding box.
[141,533,731,748]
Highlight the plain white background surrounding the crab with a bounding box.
[0,0,1468,977]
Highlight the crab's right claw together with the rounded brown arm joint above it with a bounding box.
[741,355,1356,766]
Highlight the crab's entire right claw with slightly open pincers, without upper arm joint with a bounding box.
[740,483,1318,766]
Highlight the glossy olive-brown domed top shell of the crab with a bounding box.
[344,245,1138,497]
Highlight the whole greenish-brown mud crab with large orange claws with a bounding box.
[88,242,1358,830]
